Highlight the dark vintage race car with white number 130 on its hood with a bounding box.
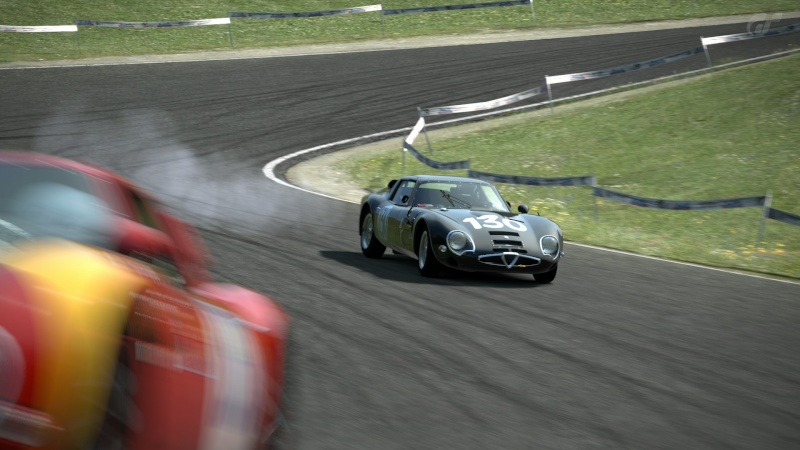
[358,175,564,283]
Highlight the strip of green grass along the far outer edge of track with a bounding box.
[0,0,798,62]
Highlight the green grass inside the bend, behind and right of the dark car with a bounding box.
[337,56,800,278]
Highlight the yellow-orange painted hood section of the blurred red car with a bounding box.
[0,240,148,446]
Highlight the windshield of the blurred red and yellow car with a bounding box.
[0,165,111,252]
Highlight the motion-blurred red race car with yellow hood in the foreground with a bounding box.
[0,152,289,450]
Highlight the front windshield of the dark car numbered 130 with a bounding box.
[413,181,509,212]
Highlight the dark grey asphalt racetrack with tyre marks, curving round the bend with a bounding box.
[0,21,800,450]
